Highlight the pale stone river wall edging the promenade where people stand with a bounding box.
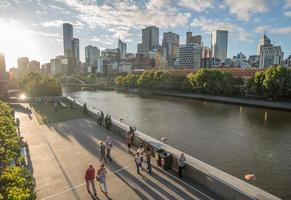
[66,97,279,200]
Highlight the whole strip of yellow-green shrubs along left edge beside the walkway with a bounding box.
[0,102,35,200]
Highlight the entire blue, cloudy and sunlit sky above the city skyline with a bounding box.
[0,0,291,68]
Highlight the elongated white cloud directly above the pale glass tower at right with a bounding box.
[191,17,253,42]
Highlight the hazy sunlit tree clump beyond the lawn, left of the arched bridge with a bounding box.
[20,73,62,97]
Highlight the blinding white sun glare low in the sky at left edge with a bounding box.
[0,21,36,67]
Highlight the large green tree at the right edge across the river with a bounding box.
[246,66,291,98]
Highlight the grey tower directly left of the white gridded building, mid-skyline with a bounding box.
[162,32,180,66]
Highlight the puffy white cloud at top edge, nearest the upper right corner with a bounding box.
[224,0,269,21]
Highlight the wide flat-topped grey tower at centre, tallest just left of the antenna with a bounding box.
[142,26,159,52]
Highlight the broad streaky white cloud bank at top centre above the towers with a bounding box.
[60,0,190,29]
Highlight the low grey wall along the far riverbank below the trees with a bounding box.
[116,88,291,112]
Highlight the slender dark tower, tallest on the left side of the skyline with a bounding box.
[63,23,73,57]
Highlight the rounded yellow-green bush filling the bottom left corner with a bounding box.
[0,167,36,200]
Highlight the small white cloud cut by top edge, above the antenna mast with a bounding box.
[178,0,213,12]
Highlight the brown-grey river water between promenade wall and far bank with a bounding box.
[65,91,291,199]
